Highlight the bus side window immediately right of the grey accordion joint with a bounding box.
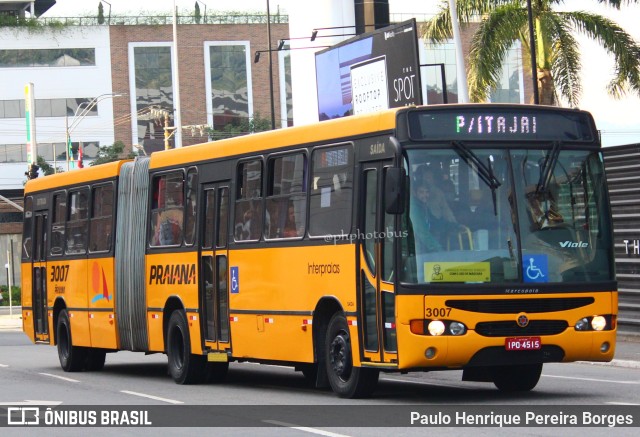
[150,171,184,247]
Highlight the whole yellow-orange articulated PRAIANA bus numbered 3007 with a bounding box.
[22,104,617,397]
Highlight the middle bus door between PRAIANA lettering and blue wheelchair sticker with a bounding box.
[199,181,231,354]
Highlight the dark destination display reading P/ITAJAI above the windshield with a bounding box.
[409,106,597,142]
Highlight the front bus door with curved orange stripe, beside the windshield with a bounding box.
[358,160,397,364]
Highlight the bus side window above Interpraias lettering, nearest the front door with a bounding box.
[309,146,353,237]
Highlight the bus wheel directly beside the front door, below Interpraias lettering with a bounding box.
[325,313,379,398]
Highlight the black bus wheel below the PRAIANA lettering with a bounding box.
[167,311,207,384]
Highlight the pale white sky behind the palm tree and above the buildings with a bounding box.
[44,0,640,146]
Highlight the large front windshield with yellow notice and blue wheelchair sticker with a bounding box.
[399,142,614,285]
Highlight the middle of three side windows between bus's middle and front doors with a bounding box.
[265,153,307,239]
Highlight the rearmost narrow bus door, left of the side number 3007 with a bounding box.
[31,211,49,343]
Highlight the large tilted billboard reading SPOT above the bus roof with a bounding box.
[316,19,422,121]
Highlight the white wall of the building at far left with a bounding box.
[0,26,114,189]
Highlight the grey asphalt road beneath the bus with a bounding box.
[0,331,640,436]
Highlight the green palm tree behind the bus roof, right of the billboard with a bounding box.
[424,0,640,106]
